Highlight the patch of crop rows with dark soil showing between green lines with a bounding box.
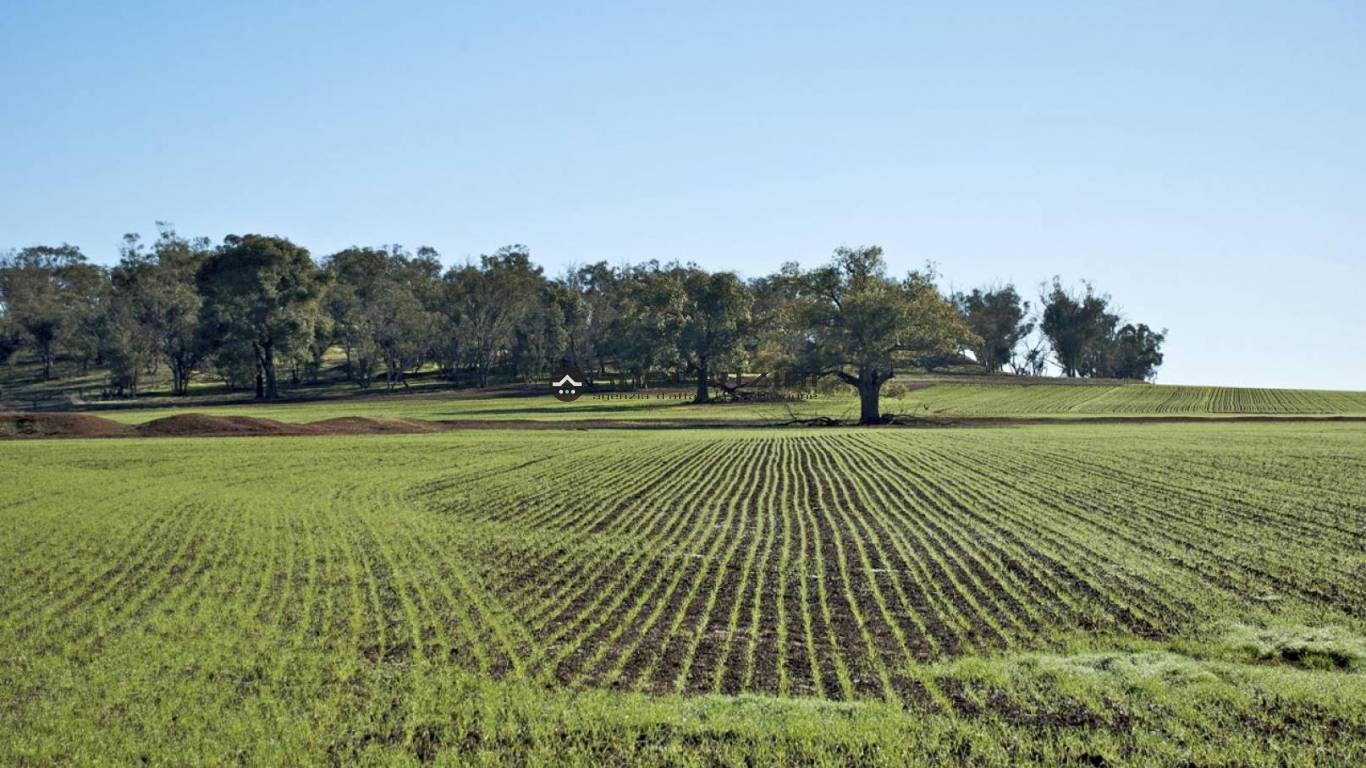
[422,430,1366,698]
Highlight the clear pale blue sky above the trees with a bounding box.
[0,0,1366,389]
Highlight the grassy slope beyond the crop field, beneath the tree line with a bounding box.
[0,355,1366,424]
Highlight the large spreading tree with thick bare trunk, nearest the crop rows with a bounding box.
[794,246,979,424]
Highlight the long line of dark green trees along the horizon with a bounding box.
[0,224,1165,421]
